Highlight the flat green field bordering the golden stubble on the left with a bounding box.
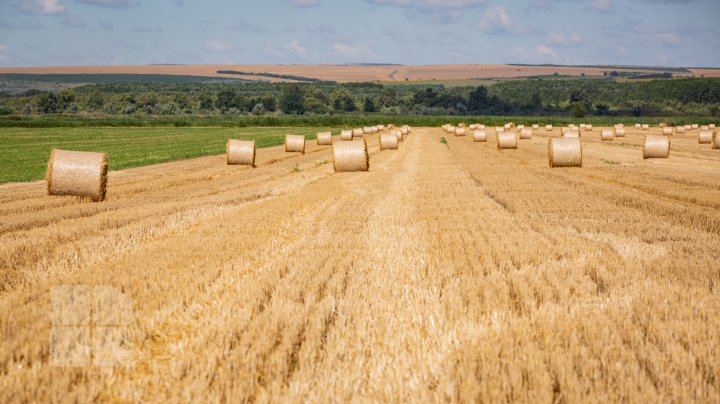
[0,127,326,184]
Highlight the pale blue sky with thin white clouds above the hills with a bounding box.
[0,0,720,67]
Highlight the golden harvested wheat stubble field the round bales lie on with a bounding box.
[0,127,720,403]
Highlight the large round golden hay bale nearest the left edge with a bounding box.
[45,149,108,202]
